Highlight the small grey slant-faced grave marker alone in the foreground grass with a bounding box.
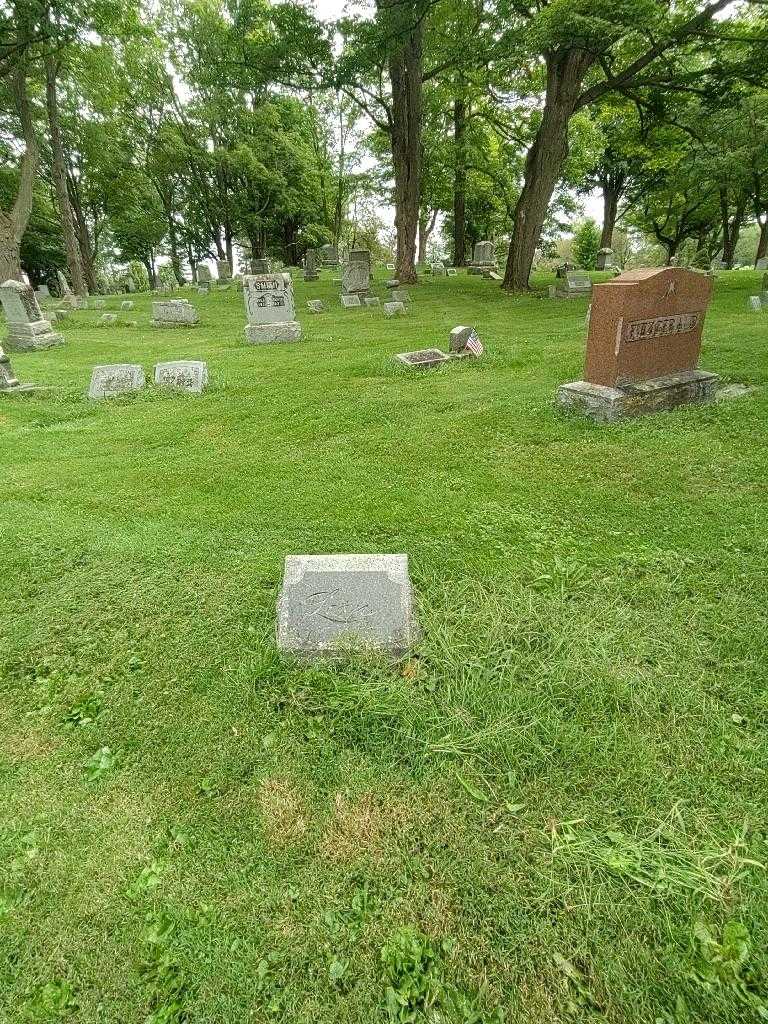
[276,555,419,657]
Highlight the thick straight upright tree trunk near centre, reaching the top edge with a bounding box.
[377,0,424,285]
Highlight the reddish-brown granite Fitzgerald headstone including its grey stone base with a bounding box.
[557,267,718,421]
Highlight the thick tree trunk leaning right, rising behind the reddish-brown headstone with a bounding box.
[502,49,594,292]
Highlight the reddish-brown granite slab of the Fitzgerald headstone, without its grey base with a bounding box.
[584,267,713,387]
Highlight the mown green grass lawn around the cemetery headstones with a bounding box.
[0,271,768,1024]
